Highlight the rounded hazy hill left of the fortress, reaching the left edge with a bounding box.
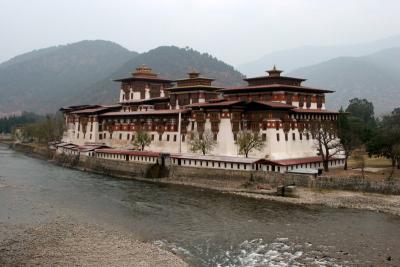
[0,40,137,113]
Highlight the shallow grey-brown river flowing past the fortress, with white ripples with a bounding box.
[0,145,400,266]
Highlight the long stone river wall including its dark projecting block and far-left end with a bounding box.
[12,144,400,195]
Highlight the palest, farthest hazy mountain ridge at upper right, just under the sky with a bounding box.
[238,35,400,76]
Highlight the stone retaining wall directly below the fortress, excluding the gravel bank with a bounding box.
[77,156,400,195]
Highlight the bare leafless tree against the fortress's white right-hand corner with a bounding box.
[310,121,342,172]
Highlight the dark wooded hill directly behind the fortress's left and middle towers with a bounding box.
[71,46,244,104]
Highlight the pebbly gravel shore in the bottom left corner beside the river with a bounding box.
[0,220,187,267]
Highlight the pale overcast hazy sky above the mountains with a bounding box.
[0,0,400,65]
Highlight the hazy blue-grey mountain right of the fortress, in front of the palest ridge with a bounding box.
[289,47,400,114]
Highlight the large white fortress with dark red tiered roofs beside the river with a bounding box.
[61,65,343,172]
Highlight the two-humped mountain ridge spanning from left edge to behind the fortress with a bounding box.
[0,40,243,113]
